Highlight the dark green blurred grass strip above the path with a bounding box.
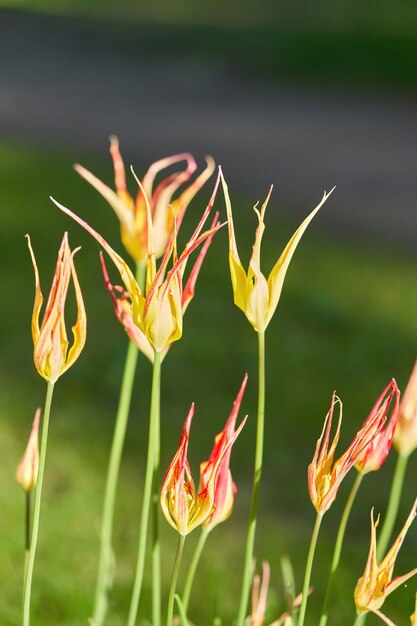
[0,0,417,93]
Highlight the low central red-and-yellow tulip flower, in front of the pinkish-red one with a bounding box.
[160,388,247,536]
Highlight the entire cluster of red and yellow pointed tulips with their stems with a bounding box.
[16,137,417,626]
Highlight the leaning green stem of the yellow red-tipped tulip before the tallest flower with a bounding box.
[127,352,161,626]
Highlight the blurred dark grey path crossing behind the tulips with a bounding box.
[0,12,417,249]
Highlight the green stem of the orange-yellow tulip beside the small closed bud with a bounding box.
[23,382,54,626]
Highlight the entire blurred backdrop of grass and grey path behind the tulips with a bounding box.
[0,0,417,626]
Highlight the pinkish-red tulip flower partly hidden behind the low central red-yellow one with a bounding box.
[199,374,248,531]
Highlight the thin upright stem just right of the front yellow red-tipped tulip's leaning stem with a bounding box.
[152,364,161,626]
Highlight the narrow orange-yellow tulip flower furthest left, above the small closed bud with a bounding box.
[26,233,87,383]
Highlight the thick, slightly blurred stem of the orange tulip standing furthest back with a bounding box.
[93,264,146,626]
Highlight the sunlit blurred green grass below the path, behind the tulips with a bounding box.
[0,142,417,626]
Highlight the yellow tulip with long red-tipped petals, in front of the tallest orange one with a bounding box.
[52,177,222,352]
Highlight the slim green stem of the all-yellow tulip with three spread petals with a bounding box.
[236,332,265,626]
